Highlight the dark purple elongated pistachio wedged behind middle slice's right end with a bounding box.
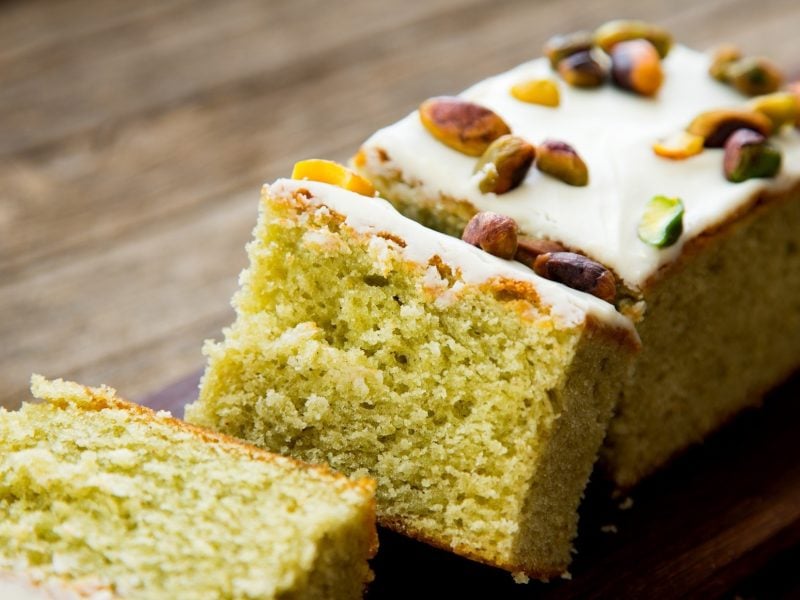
[533,252,617,302]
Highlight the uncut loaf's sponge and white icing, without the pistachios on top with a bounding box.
[353,46,800,488]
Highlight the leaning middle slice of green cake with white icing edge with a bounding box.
[186,180,637,578]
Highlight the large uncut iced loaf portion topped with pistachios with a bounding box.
[353,21,800,488]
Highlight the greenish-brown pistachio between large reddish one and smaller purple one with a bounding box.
[474,135,536,194]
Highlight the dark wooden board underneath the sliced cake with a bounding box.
[142,372,800,599]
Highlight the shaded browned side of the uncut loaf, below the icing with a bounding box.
[602,186,800,488]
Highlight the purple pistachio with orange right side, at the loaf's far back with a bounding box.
[611,40,664,96]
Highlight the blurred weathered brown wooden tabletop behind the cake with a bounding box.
[0,0,800,405]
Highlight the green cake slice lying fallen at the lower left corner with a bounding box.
[0,376,377,600]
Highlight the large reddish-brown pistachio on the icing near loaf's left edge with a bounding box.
[419,96,511,156]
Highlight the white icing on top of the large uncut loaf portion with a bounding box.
[364,46,800,287]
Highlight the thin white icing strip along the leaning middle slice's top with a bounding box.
[267,179,638,340]
